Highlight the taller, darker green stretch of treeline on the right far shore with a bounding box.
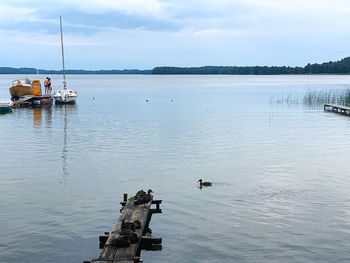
[152,57,350,75]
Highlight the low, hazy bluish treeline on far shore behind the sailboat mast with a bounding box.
[0,67,152,74]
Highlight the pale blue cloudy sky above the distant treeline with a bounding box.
[0,0,350,69]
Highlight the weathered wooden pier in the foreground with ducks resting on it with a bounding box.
[84,190,162,263]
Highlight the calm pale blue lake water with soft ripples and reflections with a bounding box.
[0,75,350,263]
